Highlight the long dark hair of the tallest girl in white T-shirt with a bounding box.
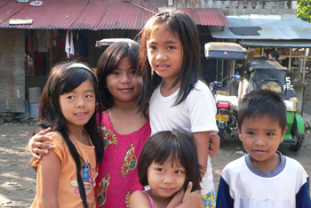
[137,10,201,117]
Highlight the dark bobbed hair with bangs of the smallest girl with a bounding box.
[137,130,201,190]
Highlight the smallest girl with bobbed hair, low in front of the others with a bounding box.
[130,130,204,208]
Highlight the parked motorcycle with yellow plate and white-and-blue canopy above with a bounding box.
[205,42,247,139]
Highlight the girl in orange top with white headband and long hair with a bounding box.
[32,63,103,208]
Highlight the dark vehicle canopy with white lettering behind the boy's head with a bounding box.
[246,59,295,99]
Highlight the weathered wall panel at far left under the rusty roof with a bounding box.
[0,29,25,112]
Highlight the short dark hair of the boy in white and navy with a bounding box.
[238,90,287,131]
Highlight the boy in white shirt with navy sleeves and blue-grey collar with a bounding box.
[216,90,311,208]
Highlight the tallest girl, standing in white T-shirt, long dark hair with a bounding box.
[138,11,218,207]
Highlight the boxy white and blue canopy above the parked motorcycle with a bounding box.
[204,42,247,60]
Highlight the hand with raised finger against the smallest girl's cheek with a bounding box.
[183,181,204,208]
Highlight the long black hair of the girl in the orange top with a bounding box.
[39,62,104,207]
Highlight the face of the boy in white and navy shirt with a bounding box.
[239,116,287,168]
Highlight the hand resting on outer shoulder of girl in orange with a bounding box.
[28,127,52,160]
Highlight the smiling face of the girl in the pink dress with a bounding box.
[107,57,143,102]
